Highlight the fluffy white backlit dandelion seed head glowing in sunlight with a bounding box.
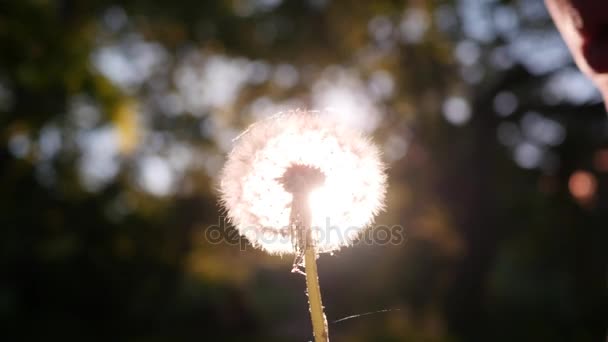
[220,111,386,254]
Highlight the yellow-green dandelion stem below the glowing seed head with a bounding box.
[304,243,329,342]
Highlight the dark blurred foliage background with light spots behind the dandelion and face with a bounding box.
[0,0,608,341]
